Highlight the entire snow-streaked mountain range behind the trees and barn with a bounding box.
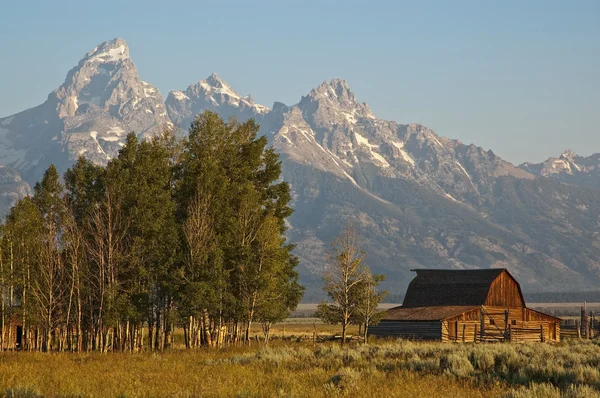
[0,39,600,300]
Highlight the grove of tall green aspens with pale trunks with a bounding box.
[0,112,304,352]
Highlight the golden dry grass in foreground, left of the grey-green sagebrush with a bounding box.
[0,343,500,398]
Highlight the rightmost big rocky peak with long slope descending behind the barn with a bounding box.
[263,79,600,292]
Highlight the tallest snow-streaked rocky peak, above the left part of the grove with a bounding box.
[0,39,171,183]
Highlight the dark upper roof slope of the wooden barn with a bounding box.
[402,268,512,308]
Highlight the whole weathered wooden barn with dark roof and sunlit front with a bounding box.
[369,268,560,342]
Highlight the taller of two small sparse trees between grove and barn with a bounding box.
[317,224,370,345]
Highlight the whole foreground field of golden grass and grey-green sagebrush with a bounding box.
[0,319,600,398]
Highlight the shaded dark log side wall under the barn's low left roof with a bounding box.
[368,321,442,340]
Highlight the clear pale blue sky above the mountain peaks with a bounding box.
[0,0,600,163]
